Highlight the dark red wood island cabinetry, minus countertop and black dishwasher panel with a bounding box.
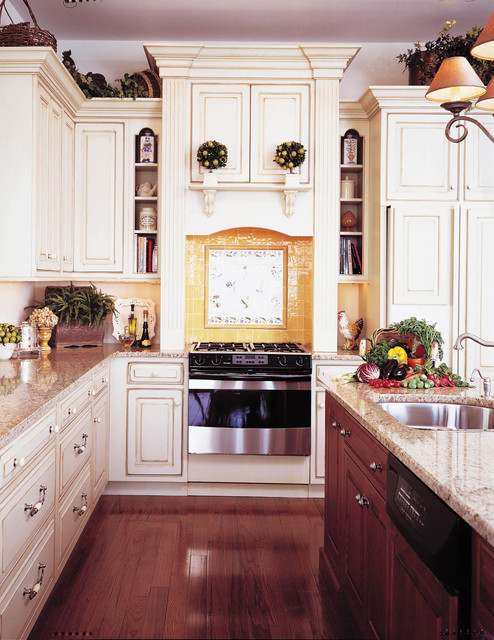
[320,393,464,640]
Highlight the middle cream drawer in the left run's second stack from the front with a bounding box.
[59,407,93,494]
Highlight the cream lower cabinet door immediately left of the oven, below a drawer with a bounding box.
[127,389,183,476]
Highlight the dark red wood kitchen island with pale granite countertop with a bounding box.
[319,374,494,640]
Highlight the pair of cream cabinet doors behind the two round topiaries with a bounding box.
[190,84,310,184]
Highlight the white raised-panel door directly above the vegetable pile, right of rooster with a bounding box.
[388,202,455,305]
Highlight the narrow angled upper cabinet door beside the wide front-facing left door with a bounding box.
[61,113,75,272]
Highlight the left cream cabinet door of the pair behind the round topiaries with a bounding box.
[190,84,250,182]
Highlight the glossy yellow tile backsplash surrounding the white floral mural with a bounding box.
[185,227,313,348]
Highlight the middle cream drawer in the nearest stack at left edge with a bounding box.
[0,451,55,574]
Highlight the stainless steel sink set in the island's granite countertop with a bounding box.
[378,402,494,431]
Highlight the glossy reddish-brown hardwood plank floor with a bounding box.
[29,496,359,640]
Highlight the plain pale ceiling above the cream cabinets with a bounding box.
[8,0,493,44]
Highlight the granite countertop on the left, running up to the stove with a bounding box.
[0,343,188,448]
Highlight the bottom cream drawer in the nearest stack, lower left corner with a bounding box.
[0,524,55,640]
